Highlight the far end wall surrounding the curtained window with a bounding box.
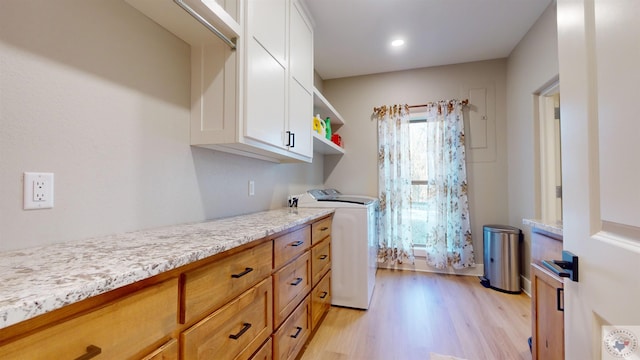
[323,59,509,264]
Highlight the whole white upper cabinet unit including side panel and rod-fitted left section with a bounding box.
[126,0,313,162]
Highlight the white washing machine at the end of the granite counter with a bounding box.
[298,189,378,309]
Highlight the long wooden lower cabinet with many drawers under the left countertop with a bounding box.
[0,216,338,360]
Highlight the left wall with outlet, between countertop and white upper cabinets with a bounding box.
[0,0,323,250]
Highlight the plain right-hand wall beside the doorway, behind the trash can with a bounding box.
[507,2,562,278]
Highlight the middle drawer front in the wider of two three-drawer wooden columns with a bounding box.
[273,251,311,328]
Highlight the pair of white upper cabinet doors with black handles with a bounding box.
[244,0,313,162]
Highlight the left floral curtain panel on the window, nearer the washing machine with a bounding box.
[374,105,414,263]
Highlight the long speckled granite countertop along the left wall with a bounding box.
[0,208,333,329]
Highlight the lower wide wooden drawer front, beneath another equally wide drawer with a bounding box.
[180,278,273,360]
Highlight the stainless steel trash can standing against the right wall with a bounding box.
[481,225,522,294]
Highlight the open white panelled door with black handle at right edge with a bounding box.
[557,0,640,360]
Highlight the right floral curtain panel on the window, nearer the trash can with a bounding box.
[422,100,475,269]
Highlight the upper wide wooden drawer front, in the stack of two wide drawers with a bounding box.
[180,241,273,324]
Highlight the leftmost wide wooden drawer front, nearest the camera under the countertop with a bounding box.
[0,279,178,360]
